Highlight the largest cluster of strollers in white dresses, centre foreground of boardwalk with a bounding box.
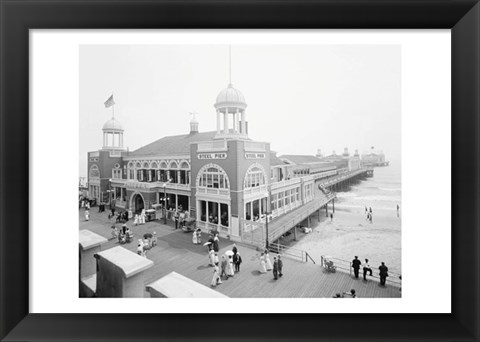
[208,242,242,287]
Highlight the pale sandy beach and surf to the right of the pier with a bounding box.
[295,163,402,274]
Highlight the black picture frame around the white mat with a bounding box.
[0,0,480,341]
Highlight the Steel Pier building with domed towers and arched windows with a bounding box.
[88,84,344,240]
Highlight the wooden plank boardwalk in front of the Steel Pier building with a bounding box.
[79,208,401,298]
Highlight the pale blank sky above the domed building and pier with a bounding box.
[79,45,401,176]
